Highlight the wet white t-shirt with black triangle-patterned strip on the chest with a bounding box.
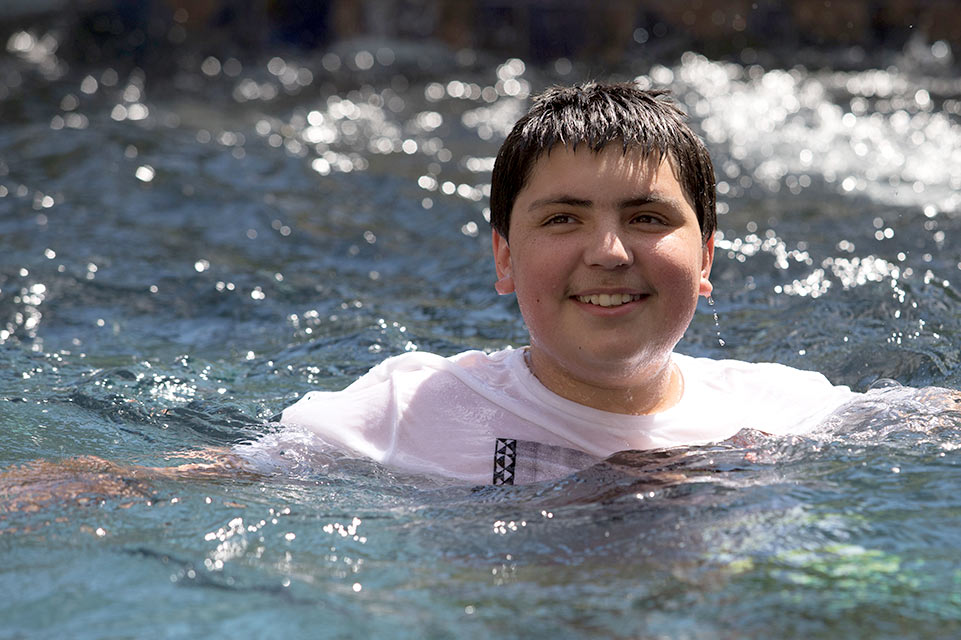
[238,349,859,484]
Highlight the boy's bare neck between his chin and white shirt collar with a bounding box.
[525,349,684,415]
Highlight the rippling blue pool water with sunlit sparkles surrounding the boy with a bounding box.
[0,22,961,638]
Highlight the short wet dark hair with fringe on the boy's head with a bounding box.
[490,82,717,241]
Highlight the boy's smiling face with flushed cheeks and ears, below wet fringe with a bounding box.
[493,145,714,397]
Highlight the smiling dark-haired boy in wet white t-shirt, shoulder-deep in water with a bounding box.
[237,83,858,484]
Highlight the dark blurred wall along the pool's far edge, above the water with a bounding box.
[0,0,961,70]
